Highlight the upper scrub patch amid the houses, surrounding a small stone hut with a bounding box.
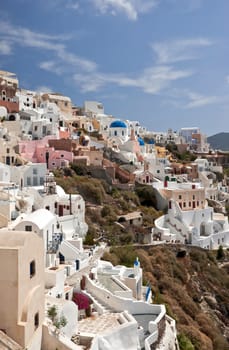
[55,169,162,245]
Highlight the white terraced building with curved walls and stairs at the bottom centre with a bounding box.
[78,259,177,350]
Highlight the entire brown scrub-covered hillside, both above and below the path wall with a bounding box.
[55,169,229,350]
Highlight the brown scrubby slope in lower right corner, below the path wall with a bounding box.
[104,245,229,350]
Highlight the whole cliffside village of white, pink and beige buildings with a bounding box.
[0,71,229,350]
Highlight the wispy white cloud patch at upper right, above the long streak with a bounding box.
[152,38,213,64]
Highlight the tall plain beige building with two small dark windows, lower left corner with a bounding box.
[0,230,44,350]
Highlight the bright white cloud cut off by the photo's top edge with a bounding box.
[91,0,158,20]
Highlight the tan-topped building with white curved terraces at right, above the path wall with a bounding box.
[153,181,229,249]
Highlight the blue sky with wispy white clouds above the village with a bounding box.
[0,0,229,135]
